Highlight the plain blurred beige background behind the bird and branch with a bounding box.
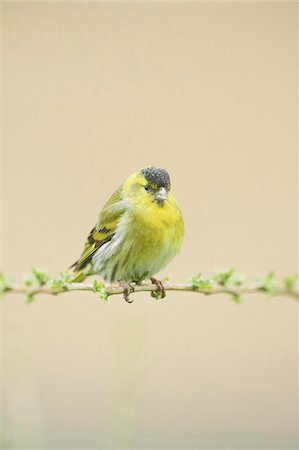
[0,3,297,450]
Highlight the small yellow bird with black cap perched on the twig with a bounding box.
[70,166,184,303]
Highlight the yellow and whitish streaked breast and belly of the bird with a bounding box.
[93,197,184,281]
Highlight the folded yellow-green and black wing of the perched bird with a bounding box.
[71,187,126,274]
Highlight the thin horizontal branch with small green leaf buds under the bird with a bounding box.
[0,268,299,303]
